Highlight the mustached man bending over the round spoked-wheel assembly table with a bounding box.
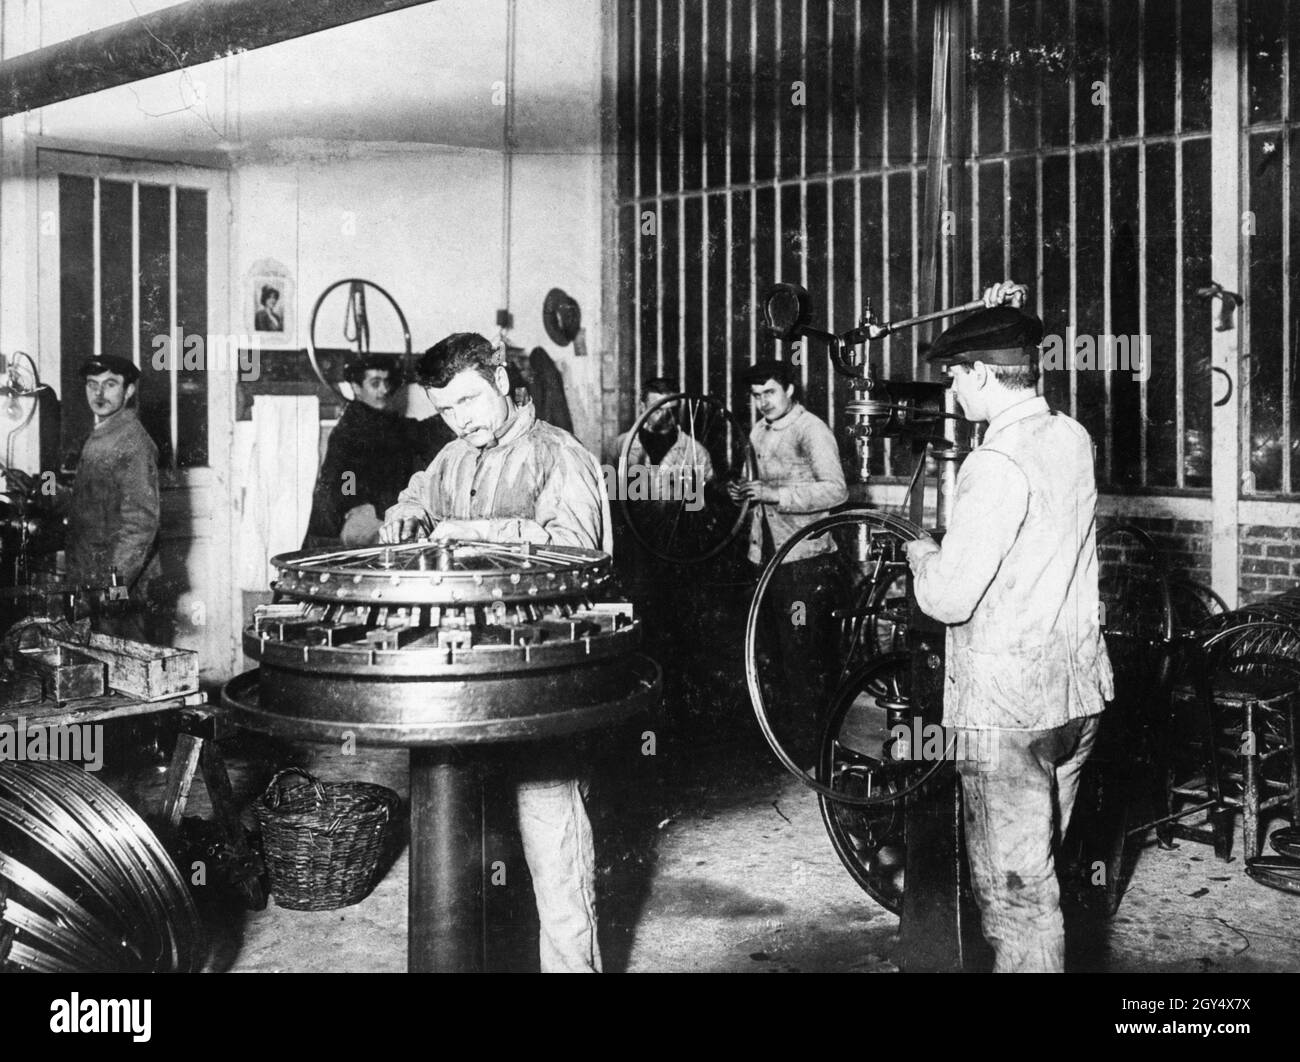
[380,333,614,972]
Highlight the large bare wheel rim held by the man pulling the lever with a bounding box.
[745,508,945,807]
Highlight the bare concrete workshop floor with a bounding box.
[139,736,1300,972]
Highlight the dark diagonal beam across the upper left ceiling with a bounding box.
[0,0,430,117]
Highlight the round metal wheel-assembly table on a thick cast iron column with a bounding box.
[222,542,660,972]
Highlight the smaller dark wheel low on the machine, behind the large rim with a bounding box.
[818,653,933,914]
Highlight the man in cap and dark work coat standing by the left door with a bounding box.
[64,355,160,638]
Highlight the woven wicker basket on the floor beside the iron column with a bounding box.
[256,767,399,911]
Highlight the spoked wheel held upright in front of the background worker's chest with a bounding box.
[618,393,757,564]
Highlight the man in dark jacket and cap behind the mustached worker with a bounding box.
[303,354,455,549]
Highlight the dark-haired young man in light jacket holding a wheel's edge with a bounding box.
[728,359,849,763]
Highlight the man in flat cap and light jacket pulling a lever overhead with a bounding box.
[907,281,1114,972]
